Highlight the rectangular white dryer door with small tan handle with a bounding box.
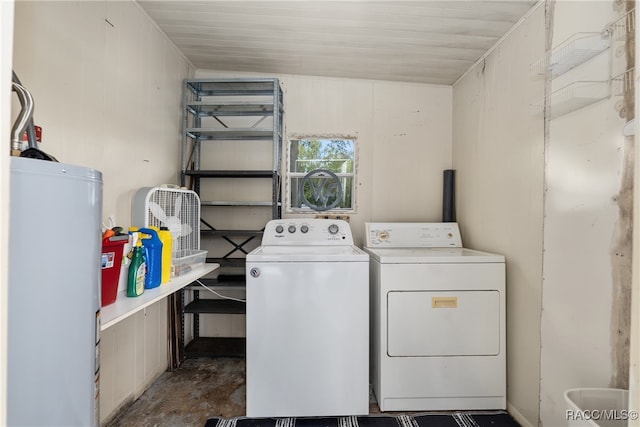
[387,290,500,357]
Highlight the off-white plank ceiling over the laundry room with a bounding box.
[138,0,537,85]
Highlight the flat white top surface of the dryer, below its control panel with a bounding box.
[364,248,505,264]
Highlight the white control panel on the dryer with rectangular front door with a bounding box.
[365,222,462,248]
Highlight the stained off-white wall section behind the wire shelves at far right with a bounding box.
[540,1,633,426]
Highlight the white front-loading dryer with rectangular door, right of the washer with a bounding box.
[365,223,506,411]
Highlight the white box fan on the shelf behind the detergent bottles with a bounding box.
[131,185,207,265]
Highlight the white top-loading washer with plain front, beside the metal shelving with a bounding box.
[246,219,369,417]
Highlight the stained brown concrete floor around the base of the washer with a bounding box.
[106,358,380,427]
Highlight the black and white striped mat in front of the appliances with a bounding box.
[205,411,520,427]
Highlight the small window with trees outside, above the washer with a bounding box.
[287,137,356,212]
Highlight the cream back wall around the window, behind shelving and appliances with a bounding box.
[197,70,452,336]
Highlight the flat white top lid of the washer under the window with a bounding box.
[247,246,369,262]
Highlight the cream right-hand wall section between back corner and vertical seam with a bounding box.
[453,7,544,426]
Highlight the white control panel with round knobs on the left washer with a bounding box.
[262,218,353,246]
